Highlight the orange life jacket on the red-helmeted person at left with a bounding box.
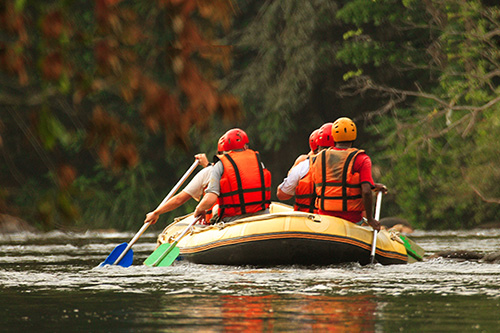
[218,149,271,218]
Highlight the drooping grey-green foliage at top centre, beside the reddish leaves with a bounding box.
[228,1,340,149]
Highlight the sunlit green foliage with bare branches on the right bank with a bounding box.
[338,0,500,229]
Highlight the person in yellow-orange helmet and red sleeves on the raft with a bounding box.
[311,117,387,230]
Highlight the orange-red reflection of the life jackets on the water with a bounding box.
[220,295,377,332]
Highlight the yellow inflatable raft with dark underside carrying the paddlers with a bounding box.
[158,202,421,266]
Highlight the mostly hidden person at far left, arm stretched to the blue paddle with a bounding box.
[144,135,228,224]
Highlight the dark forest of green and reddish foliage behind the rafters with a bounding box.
[0,0,500,230]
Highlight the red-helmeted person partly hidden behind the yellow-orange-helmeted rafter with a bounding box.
[276,123,334,213]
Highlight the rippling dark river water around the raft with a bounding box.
[0,230,500,332]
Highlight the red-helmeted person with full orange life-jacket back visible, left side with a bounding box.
[194,128,271,222]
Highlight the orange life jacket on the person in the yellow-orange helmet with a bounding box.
[312,148,365,212]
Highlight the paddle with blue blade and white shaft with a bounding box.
[99,160,199,267]
